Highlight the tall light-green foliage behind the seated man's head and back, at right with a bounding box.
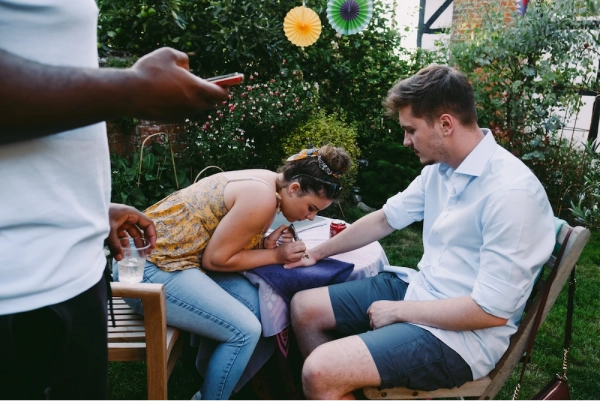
[450,0,600,222]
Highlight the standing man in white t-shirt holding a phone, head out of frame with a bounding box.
[0,0,228,400]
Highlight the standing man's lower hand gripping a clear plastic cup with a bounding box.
[106,203,156,260]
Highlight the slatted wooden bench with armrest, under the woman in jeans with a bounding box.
[108,283,182,401]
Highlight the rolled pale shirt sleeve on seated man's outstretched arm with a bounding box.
[383,174,425,230]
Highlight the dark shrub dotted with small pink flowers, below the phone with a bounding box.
[188,69,318,170]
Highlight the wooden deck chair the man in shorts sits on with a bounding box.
[363,224,590,401]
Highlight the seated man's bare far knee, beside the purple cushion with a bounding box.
[291,287,335,359]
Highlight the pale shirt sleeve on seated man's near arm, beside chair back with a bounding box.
[471,189,555,319]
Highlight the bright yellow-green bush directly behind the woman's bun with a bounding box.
[281,110,360,199]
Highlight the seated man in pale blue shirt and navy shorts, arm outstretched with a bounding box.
[285,66,555,400]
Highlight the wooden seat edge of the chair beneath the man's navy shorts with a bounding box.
[364,376,492,400]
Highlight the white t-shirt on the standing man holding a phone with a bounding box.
[0,0,110,315]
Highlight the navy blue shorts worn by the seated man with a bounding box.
[329,272,473,391]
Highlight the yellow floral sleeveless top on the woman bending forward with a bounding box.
[144,174,280,272]
